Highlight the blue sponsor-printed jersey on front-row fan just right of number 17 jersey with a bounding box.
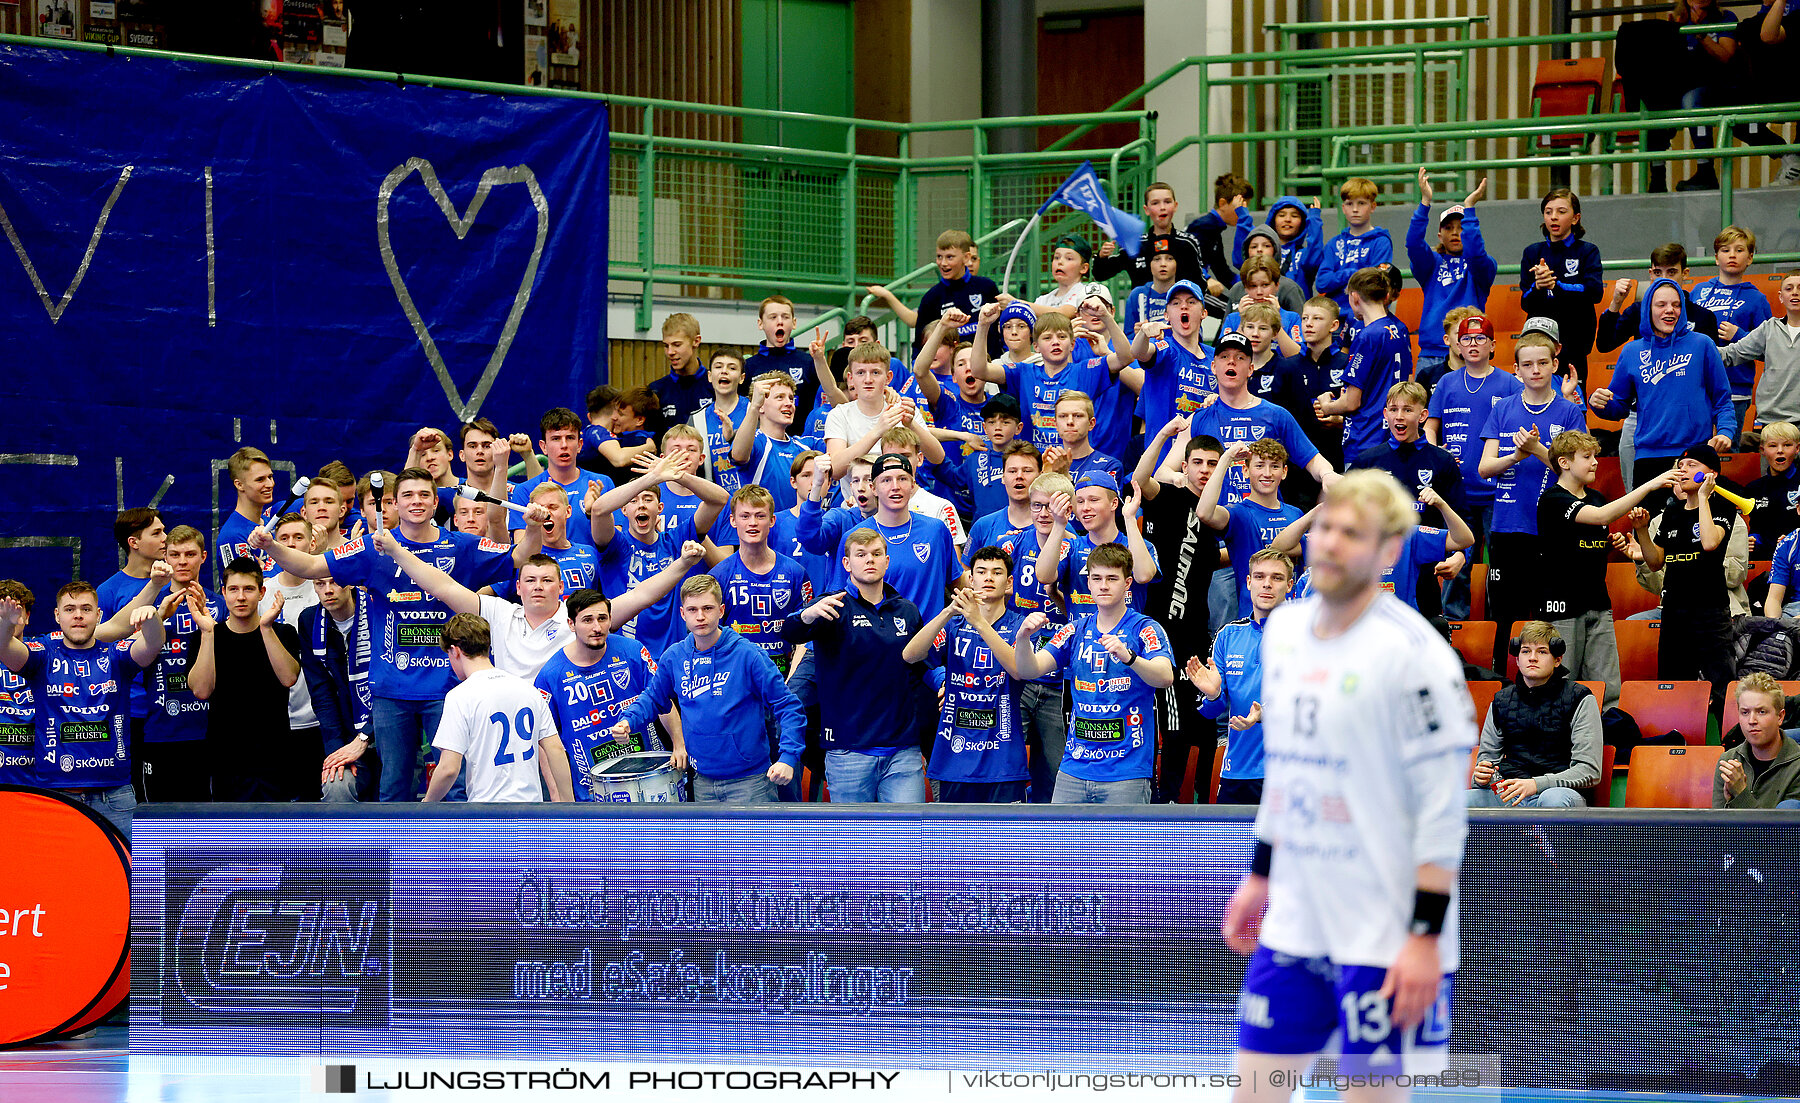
[1042,608,1175,781]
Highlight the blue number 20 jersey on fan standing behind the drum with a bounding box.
[535,632,657,801]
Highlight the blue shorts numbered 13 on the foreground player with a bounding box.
[1238,946,1454,1076]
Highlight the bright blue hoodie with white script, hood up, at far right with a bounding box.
[1595,279,1737,457]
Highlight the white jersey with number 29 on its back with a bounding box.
[432,669,556,801]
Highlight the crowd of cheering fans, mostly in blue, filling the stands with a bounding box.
[0,171,1800,826]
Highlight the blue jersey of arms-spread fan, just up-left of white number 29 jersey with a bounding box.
[326,529,517,702]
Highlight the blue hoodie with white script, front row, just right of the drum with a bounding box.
[621,628,806,781]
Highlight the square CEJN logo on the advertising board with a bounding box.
[162,849,394,1027]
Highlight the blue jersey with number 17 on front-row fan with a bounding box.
[925,608,1030,785]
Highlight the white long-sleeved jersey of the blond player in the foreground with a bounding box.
[1256,594,1476,972]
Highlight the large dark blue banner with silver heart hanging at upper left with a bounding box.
[0,45,608,615]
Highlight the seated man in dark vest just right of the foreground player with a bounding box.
[1469,621,1602,808]
